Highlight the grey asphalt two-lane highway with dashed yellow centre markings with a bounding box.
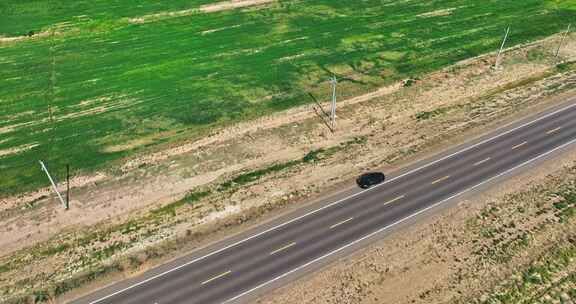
[73,100,576,304]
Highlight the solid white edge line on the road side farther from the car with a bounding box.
[222,139,576,304]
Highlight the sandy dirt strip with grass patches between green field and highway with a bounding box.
[0,32,576,301]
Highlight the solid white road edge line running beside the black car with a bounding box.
[88,103,576,304]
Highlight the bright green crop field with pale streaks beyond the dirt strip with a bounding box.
[0,0,576,197]
